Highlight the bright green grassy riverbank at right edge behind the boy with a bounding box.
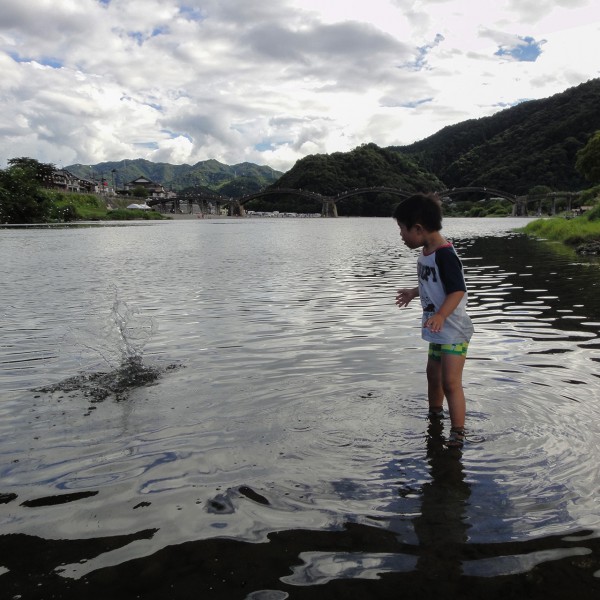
[522,205,600,247]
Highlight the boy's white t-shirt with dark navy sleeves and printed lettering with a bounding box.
[417,243,473,344]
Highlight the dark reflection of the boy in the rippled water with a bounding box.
[413,422,471,582]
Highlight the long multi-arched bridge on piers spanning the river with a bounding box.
[147,186,576,217]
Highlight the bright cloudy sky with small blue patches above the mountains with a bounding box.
[0,0,600,171]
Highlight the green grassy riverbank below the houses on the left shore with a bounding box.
[45,191,168,222]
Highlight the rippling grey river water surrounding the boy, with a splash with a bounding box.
[0,218,600,600]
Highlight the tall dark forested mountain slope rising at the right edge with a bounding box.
[388,79,600,194]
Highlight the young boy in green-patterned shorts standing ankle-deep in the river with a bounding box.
[394,194,473,448]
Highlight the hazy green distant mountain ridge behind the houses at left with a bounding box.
[65,158,282,195]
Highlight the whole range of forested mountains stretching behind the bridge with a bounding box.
[66,79,600,196]
